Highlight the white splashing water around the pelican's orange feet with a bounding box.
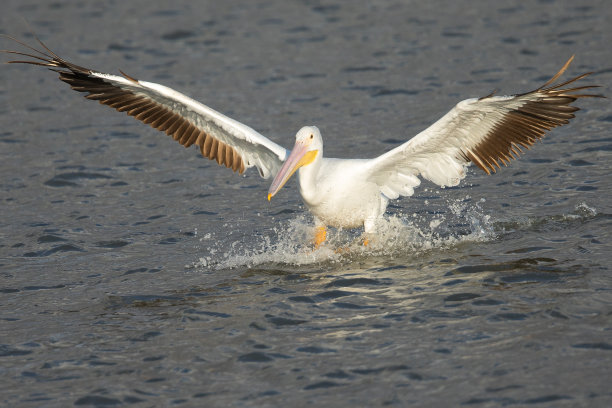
[191,196,495,269]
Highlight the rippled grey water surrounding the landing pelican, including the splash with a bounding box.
[0,0,612,407]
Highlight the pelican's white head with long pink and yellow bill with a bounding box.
[268,126,323,201]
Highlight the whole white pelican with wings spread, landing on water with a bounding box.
[4,37,601,247]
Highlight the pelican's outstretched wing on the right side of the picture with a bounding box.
[366,57,602,199]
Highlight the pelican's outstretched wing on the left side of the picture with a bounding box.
[4,37,287,178]
